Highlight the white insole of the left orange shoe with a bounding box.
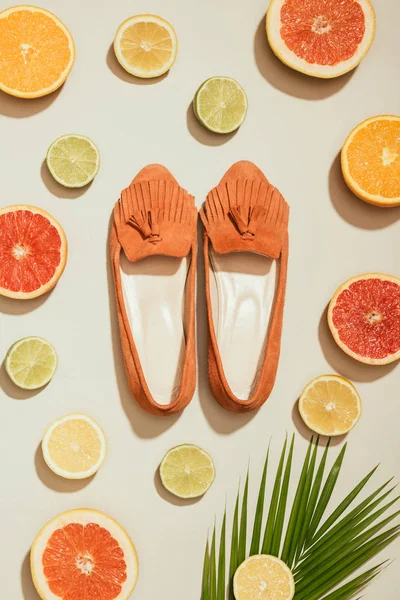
[120,252,190,405]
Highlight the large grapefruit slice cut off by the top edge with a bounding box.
[267,0,375,79]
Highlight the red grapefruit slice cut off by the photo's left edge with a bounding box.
[0,204,67,300]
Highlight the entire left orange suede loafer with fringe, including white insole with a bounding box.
[110,165,197,415]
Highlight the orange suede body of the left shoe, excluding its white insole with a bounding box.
[110,165,197,416]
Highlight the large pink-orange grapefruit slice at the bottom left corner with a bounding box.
[31,509,138,600]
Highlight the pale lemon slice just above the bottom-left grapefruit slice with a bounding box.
[42,414,107,479]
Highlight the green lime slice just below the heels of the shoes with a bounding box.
[160,444,215,498]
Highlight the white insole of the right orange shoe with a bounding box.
[210,249,278,400]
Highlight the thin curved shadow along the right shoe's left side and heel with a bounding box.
[196,220,258,435]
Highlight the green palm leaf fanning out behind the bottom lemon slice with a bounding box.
[202,436,400,600]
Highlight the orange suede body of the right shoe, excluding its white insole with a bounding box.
[200,161,289,413]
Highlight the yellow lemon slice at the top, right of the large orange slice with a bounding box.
[114,15,178,78]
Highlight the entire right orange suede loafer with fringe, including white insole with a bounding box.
[200,161,289,412]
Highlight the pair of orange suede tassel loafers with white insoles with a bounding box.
[110,161,289,415]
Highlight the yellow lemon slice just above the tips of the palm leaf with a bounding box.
[299,375,362,436]
